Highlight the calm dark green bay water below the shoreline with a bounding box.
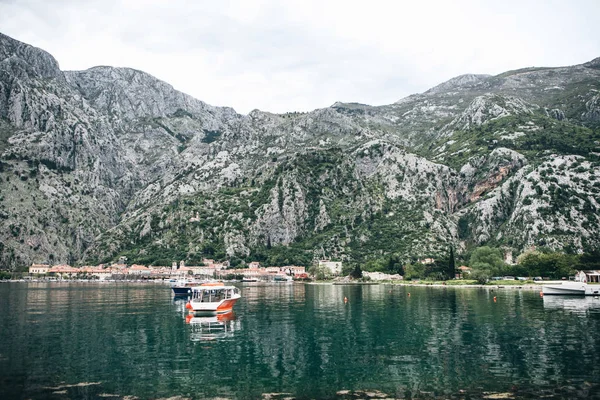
[0,283,600,399]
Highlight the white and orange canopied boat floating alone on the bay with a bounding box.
[185,282,242,314]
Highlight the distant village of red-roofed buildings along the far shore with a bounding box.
[29,257,352,281]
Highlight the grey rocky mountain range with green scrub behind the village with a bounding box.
[0,34,600,268]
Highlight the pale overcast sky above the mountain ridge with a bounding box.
[0,0,600,114]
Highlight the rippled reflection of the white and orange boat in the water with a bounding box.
[185,311,240,342]
